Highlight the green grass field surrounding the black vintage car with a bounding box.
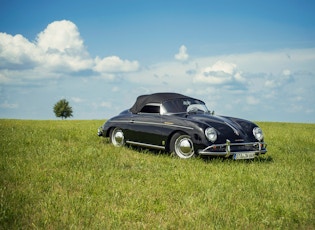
[0,120,315,229]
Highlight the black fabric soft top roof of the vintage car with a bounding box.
[130,93,195,113]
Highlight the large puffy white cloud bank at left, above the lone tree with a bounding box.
[0,20,139,83]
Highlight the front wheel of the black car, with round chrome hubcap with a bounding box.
[170,133,195,159]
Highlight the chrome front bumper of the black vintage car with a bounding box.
[198,140,267,157]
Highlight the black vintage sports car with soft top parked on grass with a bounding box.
[98,93,267,160]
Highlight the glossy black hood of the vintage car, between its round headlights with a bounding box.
[187,114,257,141]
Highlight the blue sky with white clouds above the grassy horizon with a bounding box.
[0,0,315,123]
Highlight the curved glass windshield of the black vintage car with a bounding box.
[163,98,209,113]
